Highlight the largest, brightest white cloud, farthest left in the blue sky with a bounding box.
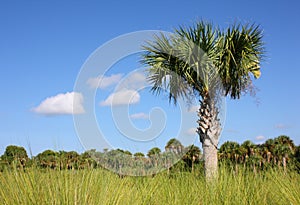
[32,92,85,115]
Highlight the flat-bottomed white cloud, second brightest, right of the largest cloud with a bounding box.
[100,90,141,106]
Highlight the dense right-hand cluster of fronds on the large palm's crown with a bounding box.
[217,24,264,99]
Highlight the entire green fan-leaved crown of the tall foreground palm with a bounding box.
[143,21,264,103]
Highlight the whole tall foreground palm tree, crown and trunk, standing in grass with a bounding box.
[142,21,264,179]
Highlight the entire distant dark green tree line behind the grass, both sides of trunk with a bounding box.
[0,135,300,175]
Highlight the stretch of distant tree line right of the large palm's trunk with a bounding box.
[218,135,300,173]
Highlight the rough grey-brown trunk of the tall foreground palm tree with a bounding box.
[197,94,221,179]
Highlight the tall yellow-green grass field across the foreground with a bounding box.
[0,168,300,205]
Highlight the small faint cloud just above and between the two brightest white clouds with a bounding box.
[87,73,123,89]
